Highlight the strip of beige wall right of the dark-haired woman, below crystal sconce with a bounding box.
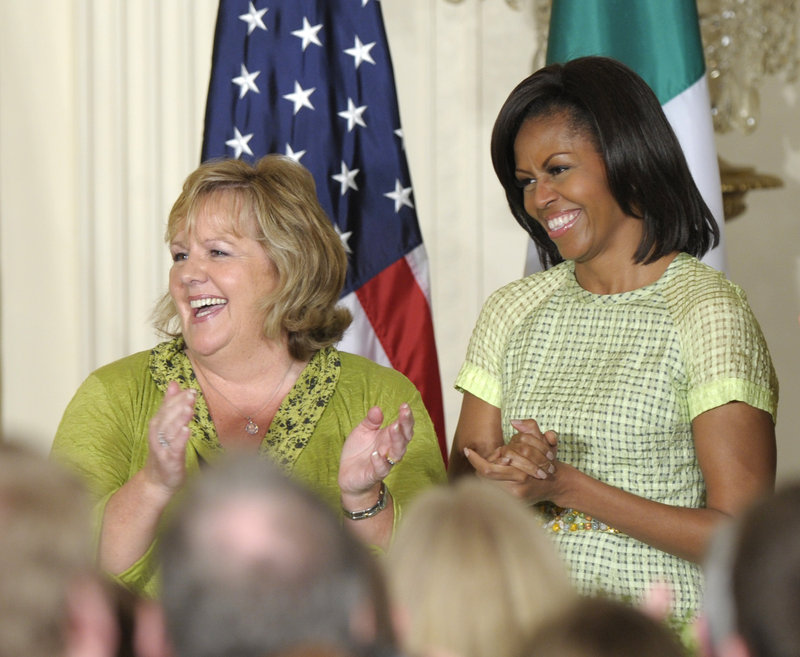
[717,78,800,479]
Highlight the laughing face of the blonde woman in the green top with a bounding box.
[169,197,278,357]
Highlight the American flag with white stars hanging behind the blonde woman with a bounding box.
[202,0,446,457]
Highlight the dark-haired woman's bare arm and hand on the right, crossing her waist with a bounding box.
[469,402,775,562]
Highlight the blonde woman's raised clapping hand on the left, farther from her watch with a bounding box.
[143,381,197,495]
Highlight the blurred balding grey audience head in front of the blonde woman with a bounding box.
[161,456,392,657]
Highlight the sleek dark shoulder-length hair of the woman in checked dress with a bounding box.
[492,57,719,268]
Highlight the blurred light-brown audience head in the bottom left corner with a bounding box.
[0,442,118,657]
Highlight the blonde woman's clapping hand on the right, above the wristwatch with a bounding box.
[339,404,414,496]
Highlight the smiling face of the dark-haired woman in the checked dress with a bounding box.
[514,114,642,264]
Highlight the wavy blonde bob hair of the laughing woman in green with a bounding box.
[153,155,352,360]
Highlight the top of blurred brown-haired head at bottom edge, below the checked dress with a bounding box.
[517,598,685,657]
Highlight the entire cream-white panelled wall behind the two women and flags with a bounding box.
[0,0,800,477]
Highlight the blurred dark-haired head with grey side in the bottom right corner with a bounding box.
[703,483,800,657]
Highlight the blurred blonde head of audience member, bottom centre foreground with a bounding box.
[386,477,574,657]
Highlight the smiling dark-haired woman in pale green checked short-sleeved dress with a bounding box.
[450,57,778,619]
